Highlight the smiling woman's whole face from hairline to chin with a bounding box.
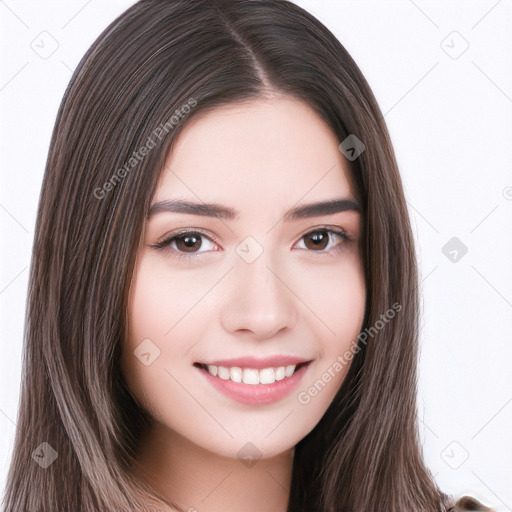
[122,96,366,458]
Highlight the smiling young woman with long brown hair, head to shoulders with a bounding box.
[4,0,489,512]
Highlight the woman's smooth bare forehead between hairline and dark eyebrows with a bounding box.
[154,96,354,209]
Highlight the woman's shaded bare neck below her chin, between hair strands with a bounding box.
[135,422,293,512]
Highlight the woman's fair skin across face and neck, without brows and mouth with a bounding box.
[122,95,366,512]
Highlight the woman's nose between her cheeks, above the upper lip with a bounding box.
[221,253,298,340]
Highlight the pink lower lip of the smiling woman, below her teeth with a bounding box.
[198,363,309,405]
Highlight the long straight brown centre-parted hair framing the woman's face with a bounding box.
[4,0,447,512]
